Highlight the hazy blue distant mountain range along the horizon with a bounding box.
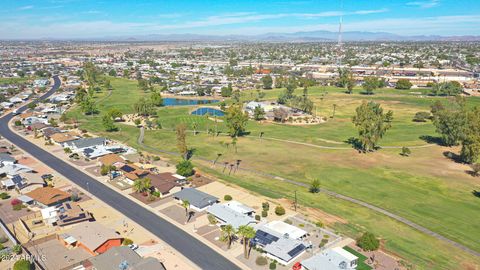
[88,31,480,42]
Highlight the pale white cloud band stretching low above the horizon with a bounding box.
[0,11,480,38]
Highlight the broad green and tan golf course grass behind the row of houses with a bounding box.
[68,79,480,269]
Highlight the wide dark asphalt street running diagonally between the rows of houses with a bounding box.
[0,76,239,270]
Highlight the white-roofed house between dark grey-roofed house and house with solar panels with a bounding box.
[207,201,256,229]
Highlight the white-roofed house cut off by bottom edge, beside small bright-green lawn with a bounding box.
[301,247,358,270]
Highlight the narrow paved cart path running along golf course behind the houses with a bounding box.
[138,128,480,257]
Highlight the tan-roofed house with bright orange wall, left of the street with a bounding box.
[62,222,123,256]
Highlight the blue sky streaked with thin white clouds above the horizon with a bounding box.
[0,0,480,39]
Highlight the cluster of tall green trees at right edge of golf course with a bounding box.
[431,97,480,163]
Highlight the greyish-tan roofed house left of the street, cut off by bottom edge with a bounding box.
[83,246,165,270]
